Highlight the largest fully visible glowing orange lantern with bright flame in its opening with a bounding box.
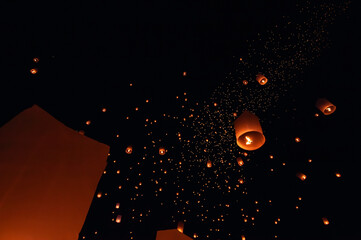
[234,111,266,150]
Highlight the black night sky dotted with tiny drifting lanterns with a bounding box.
[0,0,361,240]
